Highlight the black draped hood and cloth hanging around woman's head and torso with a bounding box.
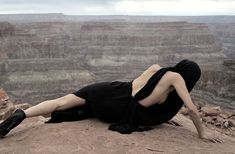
[109,59,201,134]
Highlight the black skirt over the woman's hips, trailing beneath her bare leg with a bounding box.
[46,81,132,123]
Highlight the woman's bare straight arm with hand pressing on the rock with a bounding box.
[172,73,223,143]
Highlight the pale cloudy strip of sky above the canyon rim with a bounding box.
[0,0,235,15]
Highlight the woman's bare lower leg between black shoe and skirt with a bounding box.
[24,94,86,118]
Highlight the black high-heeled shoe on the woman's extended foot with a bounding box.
[0,109,26,138]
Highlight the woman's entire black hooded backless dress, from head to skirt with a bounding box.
[45,59,201,134]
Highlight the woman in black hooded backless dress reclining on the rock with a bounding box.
[0,59,223,143]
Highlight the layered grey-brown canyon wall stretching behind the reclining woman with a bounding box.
[0,14,235,110]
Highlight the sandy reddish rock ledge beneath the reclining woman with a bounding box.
[0,88,235,154]
